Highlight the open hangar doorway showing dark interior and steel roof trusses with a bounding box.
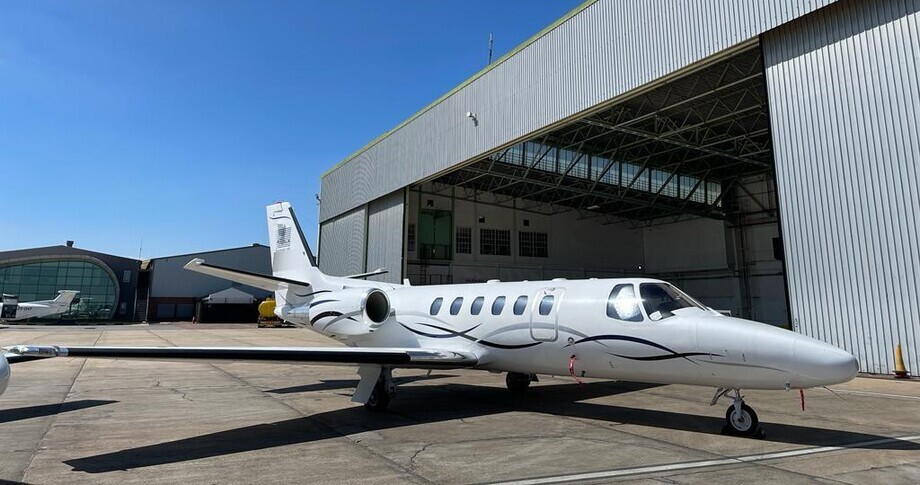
[404,43,789,327]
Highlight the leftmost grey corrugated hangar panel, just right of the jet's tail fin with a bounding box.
[319,206,367,276]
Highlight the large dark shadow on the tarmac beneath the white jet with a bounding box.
[65,381,920,473]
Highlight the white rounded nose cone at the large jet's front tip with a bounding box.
[793,337,859,387]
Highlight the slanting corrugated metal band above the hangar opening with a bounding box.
[320,0,833,221]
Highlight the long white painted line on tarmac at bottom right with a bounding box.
[494,435,920,485]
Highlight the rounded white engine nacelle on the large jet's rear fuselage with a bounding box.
[292,288,391,336]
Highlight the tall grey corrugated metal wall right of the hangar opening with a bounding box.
[763,0,920,373]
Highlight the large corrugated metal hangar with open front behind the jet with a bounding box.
[319,0,920,373]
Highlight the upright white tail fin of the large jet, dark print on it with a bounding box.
[265,202,324,305]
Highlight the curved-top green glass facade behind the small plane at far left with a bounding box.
[0,258,118,320]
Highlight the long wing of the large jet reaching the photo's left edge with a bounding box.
[0,345,478,369]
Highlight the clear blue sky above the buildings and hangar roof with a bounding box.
[0,0,581,258]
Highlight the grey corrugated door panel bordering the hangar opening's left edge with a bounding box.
[366,190,406,283]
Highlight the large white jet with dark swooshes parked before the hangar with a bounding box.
[0,202,859,436]
